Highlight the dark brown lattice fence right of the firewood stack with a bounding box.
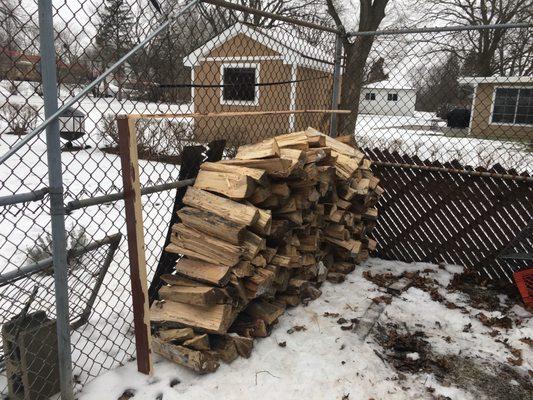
[366,149,533,279]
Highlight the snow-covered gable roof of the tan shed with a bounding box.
[183,22,334,72]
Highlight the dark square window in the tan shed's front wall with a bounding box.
[222,67,256,102]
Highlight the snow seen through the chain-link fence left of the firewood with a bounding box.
[0,81,191,395]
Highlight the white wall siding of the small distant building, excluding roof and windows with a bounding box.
[359,88,416,116]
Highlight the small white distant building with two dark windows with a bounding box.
[359,81,416,116]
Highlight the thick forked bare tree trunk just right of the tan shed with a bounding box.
[326,0,389,134]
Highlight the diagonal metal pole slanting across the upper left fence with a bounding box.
[0,0,200,165]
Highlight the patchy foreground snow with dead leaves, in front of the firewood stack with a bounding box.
[78,259,533,400]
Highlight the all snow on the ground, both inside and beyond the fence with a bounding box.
[0,82,533,399]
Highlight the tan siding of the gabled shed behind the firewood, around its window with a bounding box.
[193,34,332,145]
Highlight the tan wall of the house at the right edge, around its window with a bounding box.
[470,83,533,141]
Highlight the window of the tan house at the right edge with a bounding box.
[492,88,533,125]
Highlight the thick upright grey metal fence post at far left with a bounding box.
[39,0,74,400]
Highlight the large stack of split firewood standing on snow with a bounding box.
[150,128,383,373]
